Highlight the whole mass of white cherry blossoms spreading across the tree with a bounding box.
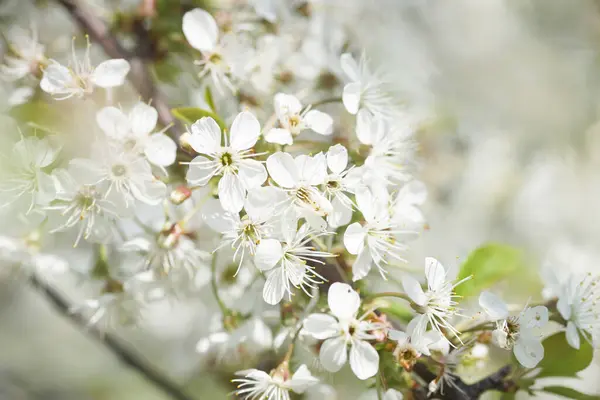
[0,1,600,400]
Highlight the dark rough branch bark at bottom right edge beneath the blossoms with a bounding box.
[413,363,511,400]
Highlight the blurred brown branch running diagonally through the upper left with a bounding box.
[57,0,181,139]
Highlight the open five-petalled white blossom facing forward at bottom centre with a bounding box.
[303,282,379,380]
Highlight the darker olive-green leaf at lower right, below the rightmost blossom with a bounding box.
[537,332,594,378]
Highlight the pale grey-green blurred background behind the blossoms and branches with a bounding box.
[0,0,600,400]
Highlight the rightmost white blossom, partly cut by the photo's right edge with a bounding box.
[556,274,600,349]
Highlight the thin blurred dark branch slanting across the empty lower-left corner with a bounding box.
[29,274,193,400]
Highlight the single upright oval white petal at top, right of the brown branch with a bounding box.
[182,8,219,51]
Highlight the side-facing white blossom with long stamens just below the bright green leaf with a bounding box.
[402,257,470,337]
